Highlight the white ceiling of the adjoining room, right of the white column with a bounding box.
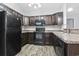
[67,3,79,18]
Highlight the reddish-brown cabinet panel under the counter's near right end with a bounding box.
[65,44,79,56]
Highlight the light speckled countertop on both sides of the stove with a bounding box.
[22,30,79,44]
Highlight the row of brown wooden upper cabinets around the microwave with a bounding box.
[23,12,63,26]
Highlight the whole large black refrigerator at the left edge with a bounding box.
[0,11,21,56]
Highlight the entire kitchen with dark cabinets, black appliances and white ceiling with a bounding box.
[0,3,79,56]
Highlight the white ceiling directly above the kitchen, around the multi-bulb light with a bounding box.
[5,3,63,16]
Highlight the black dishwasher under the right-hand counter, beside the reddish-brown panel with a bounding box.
[54,37,64,56]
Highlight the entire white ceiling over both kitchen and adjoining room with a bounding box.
[4,3,79,18]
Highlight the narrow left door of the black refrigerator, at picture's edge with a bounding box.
[0,11,5,56]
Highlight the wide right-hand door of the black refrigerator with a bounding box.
[6,15,21,56]
